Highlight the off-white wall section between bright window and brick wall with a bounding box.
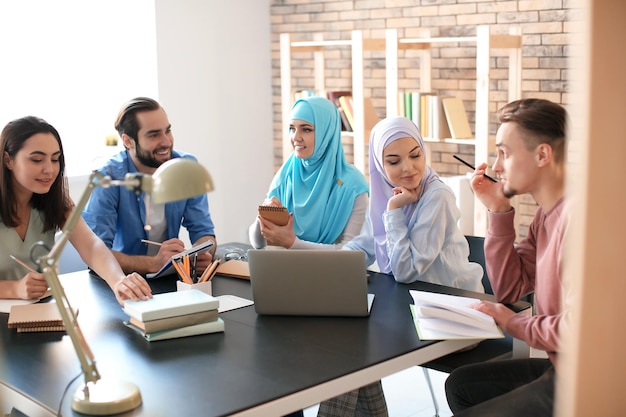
[155,0,273,243]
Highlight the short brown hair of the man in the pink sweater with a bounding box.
[498,98,567,163]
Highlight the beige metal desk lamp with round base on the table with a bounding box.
[31,158,213,415]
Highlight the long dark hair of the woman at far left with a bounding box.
[0,116,70,232]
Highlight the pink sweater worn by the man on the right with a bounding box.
[485,199,567,365]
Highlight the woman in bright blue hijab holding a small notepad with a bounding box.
[249,97,369,249]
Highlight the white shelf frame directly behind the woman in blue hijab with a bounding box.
[280,30,385,173]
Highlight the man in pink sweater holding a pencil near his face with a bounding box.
[446,99,567,417]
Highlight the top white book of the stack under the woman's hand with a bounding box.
[123,289,219,322]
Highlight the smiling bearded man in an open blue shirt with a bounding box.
[83,97,216,274]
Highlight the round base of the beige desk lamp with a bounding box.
[72,379,141,416]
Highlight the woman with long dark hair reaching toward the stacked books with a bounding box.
[0,116,152,304]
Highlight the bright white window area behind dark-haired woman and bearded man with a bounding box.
[0,0,157,175]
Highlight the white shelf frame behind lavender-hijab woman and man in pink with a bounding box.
[385,25,522,236]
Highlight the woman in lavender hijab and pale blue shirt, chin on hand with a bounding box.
[318,117,484,416]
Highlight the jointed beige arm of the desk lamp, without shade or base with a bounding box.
[37,171,142,383]
